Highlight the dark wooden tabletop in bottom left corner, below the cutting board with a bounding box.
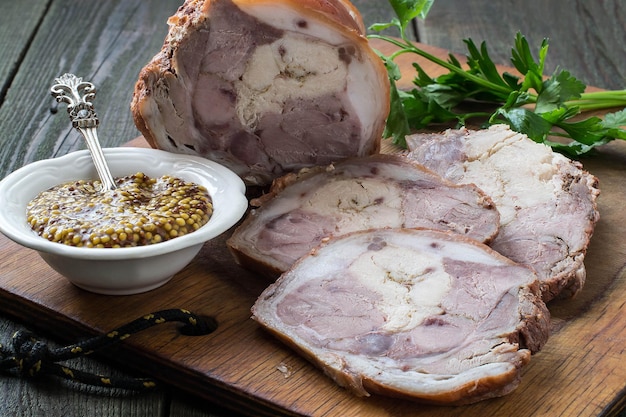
[0,310,240,417]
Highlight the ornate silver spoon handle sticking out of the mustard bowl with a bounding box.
[50,74,117,190]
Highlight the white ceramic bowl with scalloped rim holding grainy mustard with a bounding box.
[0,147,248,295]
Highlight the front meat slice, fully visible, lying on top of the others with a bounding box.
[252,229,550,405]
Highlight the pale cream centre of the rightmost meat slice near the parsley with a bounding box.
[456,130,562,225]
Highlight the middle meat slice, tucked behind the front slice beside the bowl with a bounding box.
[227,154,500,277]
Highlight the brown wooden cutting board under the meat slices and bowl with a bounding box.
[0,39,626,416]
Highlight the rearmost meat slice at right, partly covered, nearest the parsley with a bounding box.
[407,125,599,302]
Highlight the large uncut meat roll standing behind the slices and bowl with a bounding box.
[131,0,389,186]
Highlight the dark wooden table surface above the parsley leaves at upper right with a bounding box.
[418,0,626,89]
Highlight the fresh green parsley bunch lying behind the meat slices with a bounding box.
[370,0,626,157]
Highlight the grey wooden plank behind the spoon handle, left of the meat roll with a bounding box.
[0,0,180,177]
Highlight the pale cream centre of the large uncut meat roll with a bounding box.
[235,34,348,129]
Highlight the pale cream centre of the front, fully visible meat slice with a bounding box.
[349,244,452,332]
